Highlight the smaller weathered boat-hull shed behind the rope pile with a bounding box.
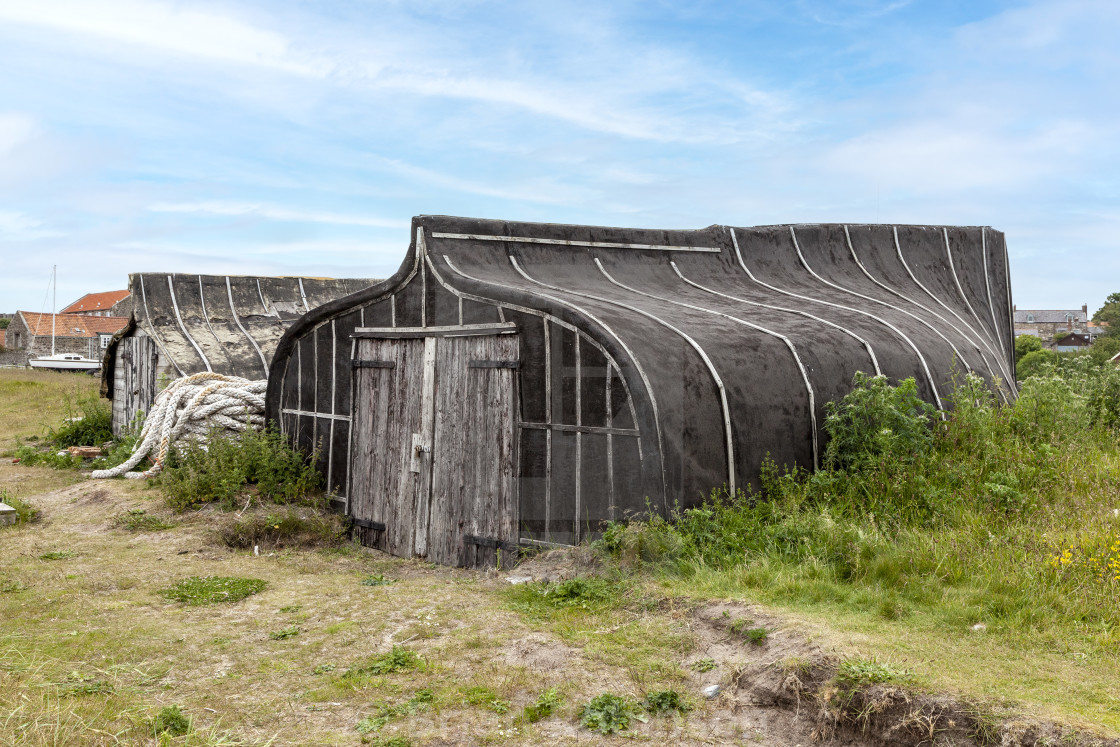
[101,272,377,433]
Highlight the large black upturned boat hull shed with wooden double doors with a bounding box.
[268,216,1016,566]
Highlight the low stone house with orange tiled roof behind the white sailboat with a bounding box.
[4,311,129,358]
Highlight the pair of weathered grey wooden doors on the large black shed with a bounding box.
[348,324,520,568]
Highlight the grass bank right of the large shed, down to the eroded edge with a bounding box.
[601,360,1120,728]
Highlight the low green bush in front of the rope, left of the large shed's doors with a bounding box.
[158,428,323,511]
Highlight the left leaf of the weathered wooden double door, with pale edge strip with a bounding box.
[349,337,436,558]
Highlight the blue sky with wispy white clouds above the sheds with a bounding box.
[0,0,1120,311]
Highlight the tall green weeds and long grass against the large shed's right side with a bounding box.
[600,365,1120,645]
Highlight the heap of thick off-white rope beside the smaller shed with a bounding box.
[90,372,268,479]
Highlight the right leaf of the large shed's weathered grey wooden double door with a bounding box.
[428,335,519,568]
